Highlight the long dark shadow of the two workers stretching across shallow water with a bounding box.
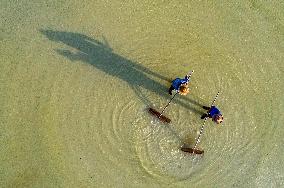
[40,30,203,115]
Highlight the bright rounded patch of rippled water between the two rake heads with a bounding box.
[132,108,205,181]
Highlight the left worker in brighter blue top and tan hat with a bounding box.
[169,75,190,95]
